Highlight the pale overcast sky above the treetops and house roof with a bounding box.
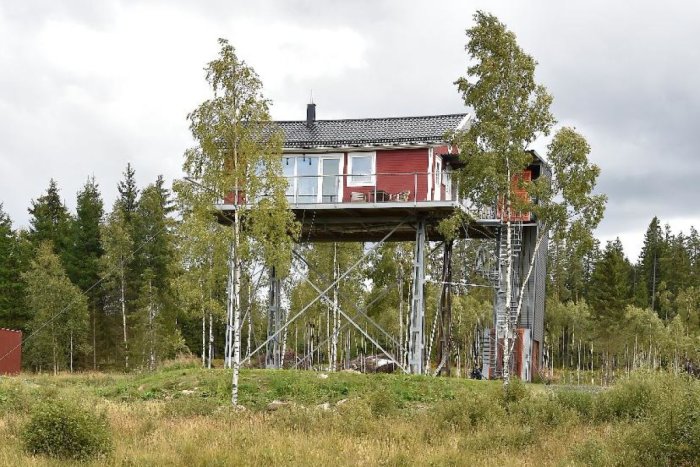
[0,0,700,260]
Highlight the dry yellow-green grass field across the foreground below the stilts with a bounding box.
[0,362,700,466]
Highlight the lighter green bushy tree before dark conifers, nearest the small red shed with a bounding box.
[23,241,89,373]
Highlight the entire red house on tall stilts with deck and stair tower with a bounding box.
[220,104,548,380]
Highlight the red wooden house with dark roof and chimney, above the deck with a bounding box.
[276,104,468,206]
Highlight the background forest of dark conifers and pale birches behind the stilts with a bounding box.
[0,170,700,378]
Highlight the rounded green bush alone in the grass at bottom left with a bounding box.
[22,400,112,460]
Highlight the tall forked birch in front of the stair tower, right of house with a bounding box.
[456,12,605,386]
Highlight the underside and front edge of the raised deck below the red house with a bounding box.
[217,201,508,242]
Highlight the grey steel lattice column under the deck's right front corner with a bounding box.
[408,219,425,375]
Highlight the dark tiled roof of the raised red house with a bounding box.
[275,114,467,148]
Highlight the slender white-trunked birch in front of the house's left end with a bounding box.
[179,39,298,405]
